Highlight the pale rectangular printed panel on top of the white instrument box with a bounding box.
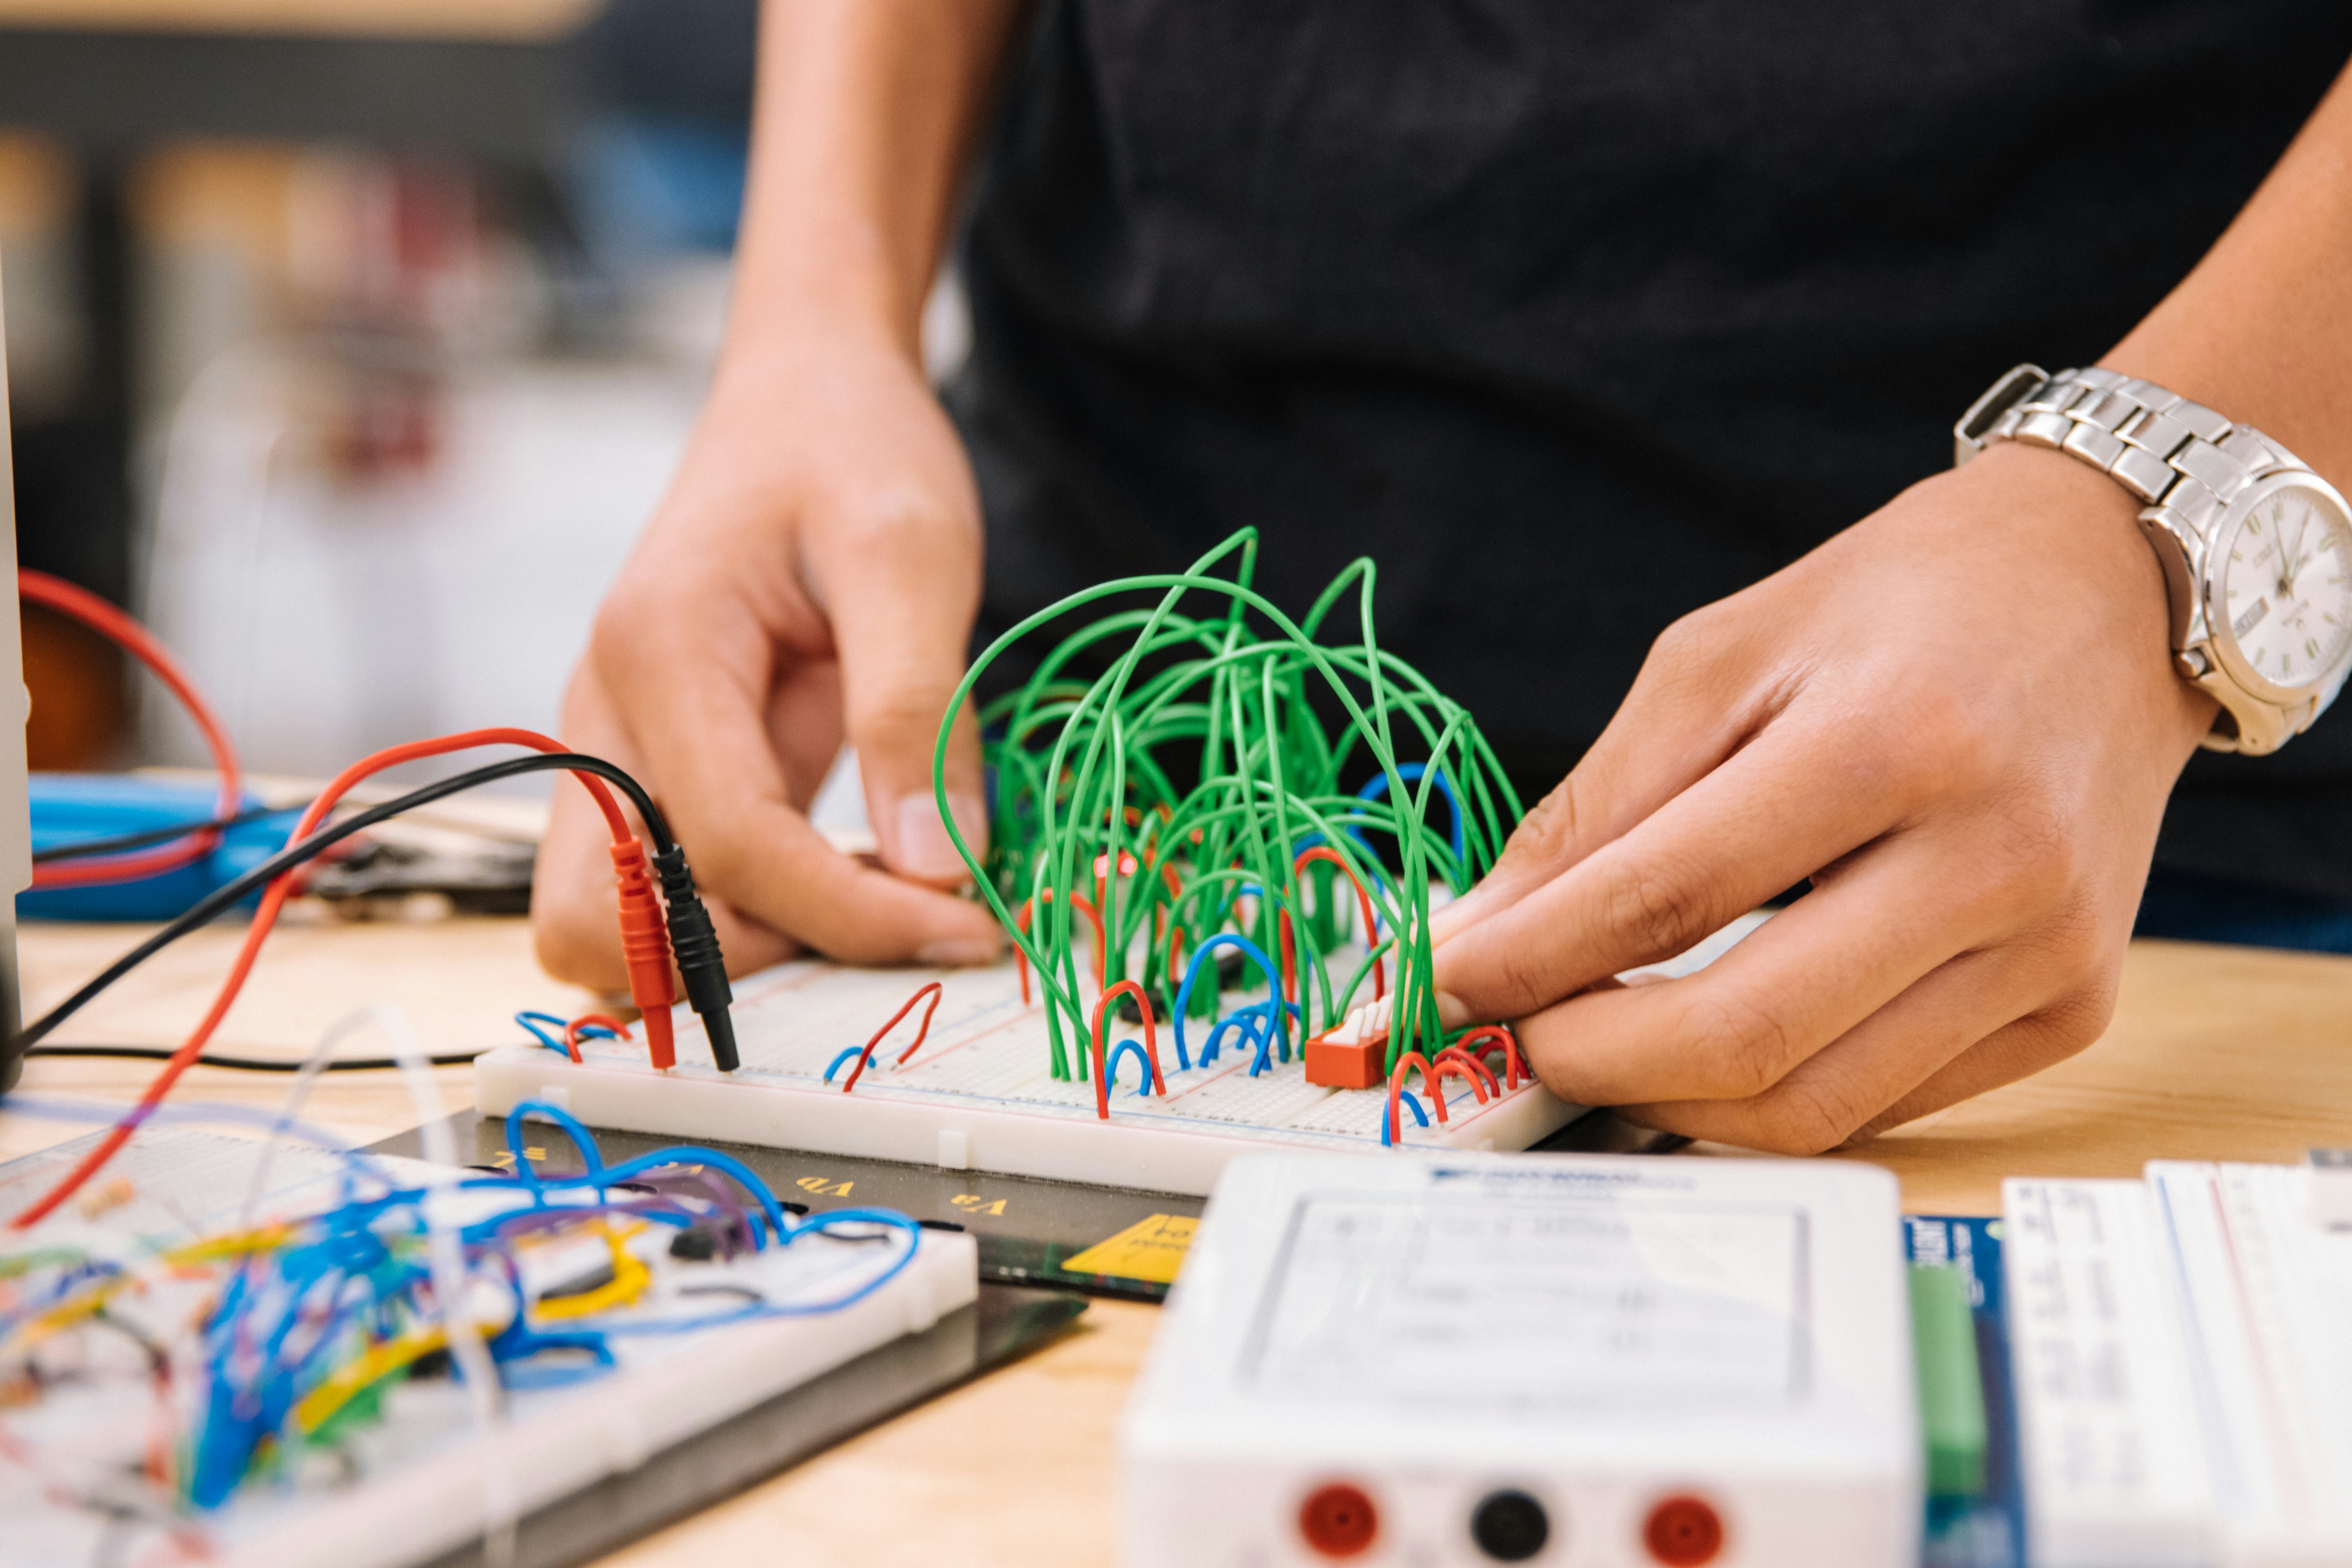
[1247,1192,1811,1415]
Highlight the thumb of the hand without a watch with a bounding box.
[823,512,988,886]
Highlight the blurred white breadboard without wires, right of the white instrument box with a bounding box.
[2002,1161,2352,1568]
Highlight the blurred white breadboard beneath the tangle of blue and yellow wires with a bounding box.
[0,1129,978,1568]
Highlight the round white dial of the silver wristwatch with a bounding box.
[2213,482,2352,691]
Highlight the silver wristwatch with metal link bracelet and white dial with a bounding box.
[1952,365,2352,752]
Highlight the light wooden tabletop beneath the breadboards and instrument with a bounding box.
[0,919,2352,1568]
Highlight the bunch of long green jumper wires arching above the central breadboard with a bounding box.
[931,529,1522,1079]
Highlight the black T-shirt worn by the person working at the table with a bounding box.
[950,0,2352,896]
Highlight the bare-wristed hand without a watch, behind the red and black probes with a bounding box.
[532,329,1002,990]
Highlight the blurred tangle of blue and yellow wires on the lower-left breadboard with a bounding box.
[0,1103,922,1521]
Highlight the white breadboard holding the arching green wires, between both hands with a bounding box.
[473,915,1764,1194]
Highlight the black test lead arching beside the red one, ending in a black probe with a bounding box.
[5,752,741,1072]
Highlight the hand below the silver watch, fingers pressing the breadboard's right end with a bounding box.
[1435,446,2213,1152]
